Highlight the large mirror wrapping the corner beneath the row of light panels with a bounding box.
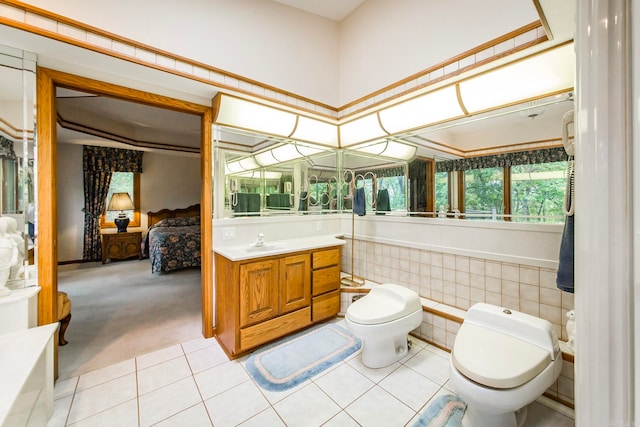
[214,92,573,222]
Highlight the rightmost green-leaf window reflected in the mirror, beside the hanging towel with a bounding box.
[511,162,567,222]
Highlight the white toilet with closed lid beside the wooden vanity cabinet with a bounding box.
[345,283,422,368]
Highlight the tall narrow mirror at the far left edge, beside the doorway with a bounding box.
[0,45,37,289]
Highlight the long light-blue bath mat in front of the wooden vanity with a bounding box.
[246,324,362,391]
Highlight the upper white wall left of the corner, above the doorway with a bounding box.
[18,0,338,105]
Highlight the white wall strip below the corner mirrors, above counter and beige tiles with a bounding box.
[213,214,562,269]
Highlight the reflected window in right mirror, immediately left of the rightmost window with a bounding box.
[464,168,504,219]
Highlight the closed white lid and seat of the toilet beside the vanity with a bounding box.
[347,283,422,325]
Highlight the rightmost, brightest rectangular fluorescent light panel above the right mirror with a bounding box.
[459,43,576,113]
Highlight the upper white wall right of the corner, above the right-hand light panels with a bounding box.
[338,0,538,105]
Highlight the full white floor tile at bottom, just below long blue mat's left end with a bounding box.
[204,381,269,427]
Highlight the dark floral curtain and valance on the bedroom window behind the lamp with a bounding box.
[82,145,143,261]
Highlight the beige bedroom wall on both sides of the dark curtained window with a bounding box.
[58,144,201,262]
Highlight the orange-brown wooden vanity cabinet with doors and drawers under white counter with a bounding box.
[215,247,340,358]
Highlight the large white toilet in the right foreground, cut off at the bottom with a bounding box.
[449,303,562,427]
